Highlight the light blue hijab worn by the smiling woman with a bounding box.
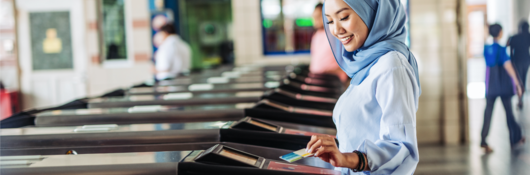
[322,0,420,86]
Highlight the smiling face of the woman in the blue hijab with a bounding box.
[325,0,368,52]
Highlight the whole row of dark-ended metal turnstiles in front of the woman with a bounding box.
[0,66,343,175]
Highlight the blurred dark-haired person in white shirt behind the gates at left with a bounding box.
[153,24,191,80]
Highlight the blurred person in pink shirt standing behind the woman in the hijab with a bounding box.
[309,3,348,82]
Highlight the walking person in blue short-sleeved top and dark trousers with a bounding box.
[480,24,525,153]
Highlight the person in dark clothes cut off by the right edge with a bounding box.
[506,21,530,108]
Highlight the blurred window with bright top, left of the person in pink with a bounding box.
[261,0,320,55]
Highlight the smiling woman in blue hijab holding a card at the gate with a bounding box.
[307,0,421,174]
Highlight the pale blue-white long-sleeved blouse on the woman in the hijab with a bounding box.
[333,51,421,175]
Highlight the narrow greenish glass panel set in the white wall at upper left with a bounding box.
[101,0,127,60]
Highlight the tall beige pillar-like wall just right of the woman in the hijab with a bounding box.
[410,0,467,144]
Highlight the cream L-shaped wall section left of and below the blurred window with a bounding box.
[232,0,311,65]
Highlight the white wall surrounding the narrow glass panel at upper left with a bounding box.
[84,0,152,96]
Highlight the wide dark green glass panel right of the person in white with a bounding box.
[179,0,234,70]
